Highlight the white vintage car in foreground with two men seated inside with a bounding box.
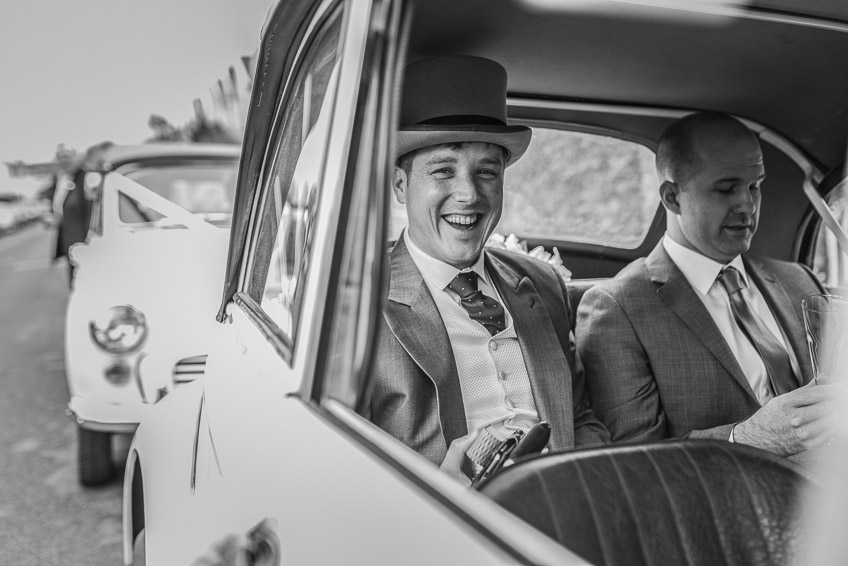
[124,0,848,566]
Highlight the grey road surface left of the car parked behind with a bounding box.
[0,225,127,566]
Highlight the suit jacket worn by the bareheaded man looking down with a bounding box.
[576,242,824,442]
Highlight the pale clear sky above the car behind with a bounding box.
[0,0,273,194]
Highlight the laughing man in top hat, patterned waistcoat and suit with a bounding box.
[366,57,608,475]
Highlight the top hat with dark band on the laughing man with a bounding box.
[396,55,532,166]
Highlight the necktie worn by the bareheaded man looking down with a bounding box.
[718,267,798,395]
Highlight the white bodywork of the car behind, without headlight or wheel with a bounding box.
[65,144,238,432]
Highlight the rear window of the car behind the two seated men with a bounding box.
[391,126,660,249]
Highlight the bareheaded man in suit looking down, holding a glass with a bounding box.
[576,113,835,462]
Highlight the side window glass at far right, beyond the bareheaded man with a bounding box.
[813,182,848,293]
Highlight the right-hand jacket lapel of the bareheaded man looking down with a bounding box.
[742,256,813,386]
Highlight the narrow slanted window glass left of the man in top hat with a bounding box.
[248,9,342,343]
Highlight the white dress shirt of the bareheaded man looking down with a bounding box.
[663,234,799,405]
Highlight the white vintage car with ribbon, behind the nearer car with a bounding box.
[65,144,240,485]
